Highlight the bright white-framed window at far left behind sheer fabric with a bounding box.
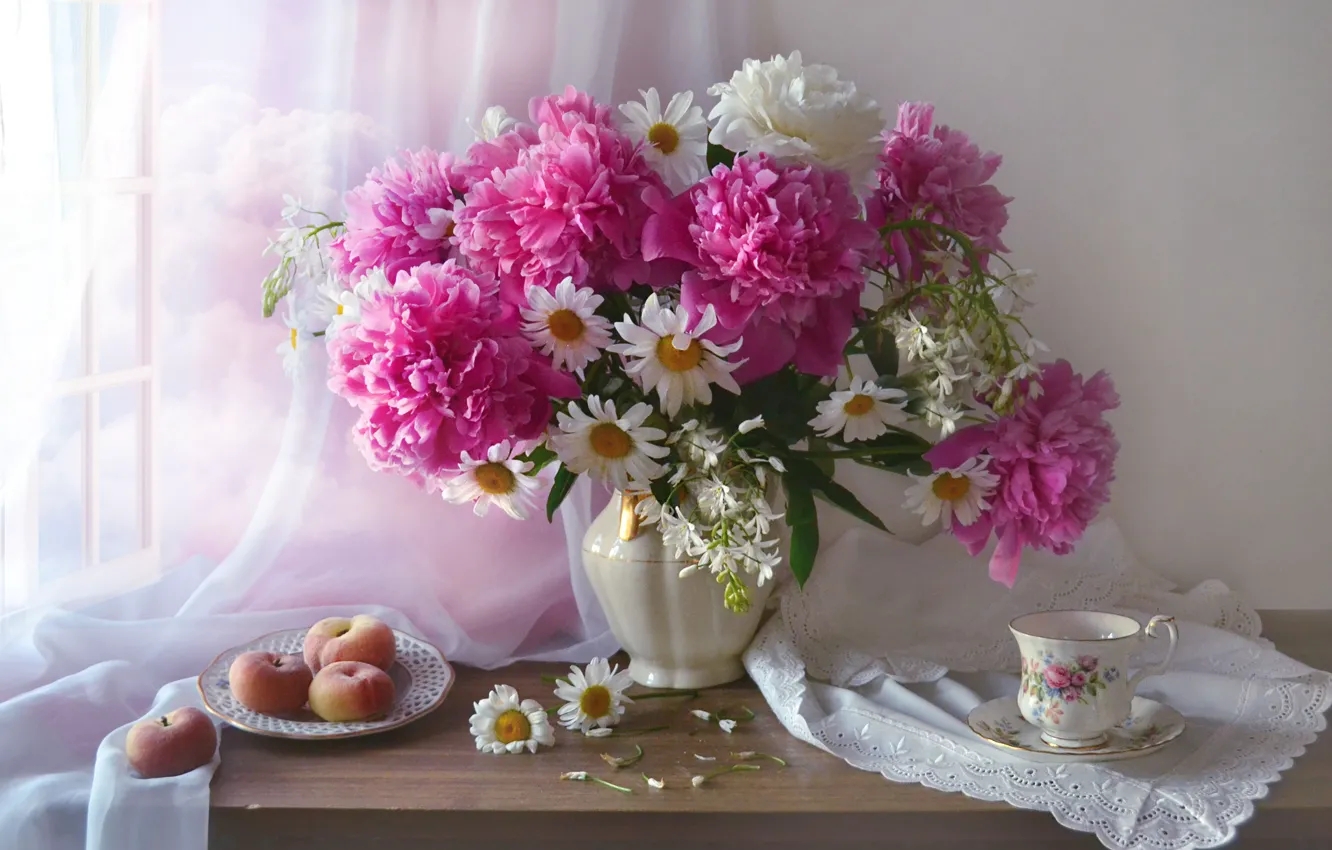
[0,0,160,612]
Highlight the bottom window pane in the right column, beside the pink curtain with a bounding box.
[97,384,144,562]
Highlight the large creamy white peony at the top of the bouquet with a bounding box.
[707,51,884,185]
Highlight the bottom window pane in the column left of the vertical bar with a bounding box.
[37,396,85,585]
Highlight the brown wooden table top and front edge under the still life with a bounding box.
[209,612,1332,850]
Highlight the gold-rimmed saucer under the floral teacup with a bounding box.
[967,697,1184,762]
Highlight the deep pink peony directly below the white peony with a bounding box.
[643,153,878,382]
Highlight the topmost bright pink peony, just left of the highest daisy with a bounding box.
[457,88,662,304]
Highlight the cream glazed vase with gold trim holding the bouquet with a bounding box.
[583,492,774,687]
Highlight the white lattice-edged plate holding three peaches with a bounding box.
[198,629,454,741]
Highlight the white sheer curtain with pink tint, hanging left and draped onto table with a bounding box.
[0,0,747,849]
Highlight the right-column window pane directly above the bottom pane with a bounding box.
[88,195,145,372]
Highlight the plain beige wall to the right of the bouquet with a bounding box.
[755,0,1332,608]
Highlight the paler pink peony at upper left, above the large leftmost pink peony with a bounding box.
[330,148,464,284]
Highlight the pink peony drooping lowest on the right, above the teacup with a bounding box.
[924,360,1119,588]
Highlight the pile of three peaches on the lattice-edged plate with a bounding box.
[228,614,397,722]
